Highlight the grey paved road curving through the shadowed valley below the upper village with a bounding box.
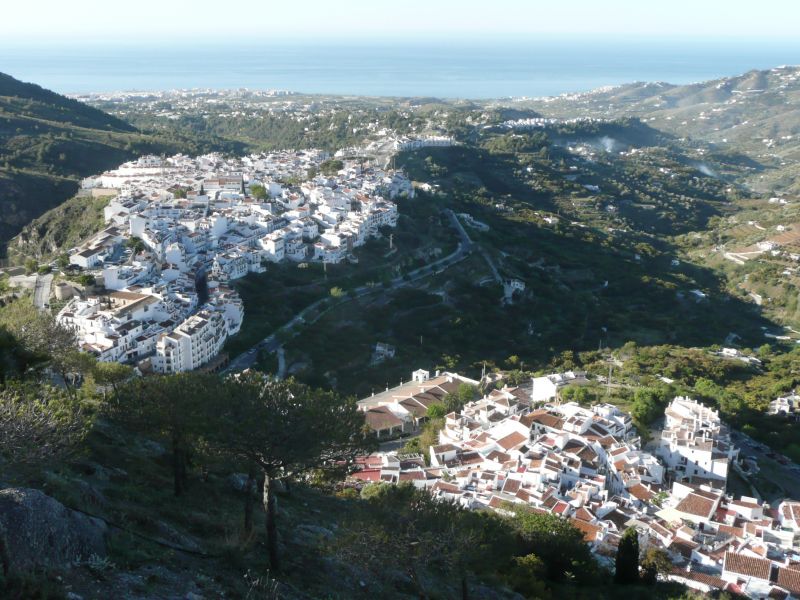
[222,209,474,373]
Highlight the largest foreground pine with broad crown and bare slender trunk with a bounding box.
[207,372,374,570]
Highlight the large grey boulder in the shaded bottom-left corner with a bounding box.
[0,488,108,574]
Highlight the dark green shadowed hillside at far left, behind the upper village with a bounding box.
[0,73,200,247]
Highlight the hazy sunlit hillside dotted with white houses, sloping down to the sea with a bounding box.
[515,66,800,193]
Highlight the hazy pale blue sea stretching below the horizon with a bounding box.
[0,38,800,99]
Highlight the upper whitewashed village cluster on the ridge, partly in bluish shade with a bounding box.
[56,150,413,373]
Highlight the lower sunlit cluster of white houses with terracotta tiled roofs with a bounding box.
[350,369,800,598]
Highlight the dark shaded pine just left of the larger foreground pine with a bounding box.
[106,373,227,496]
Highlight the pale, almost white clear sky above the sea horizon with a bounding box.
[0,0,800,42]
